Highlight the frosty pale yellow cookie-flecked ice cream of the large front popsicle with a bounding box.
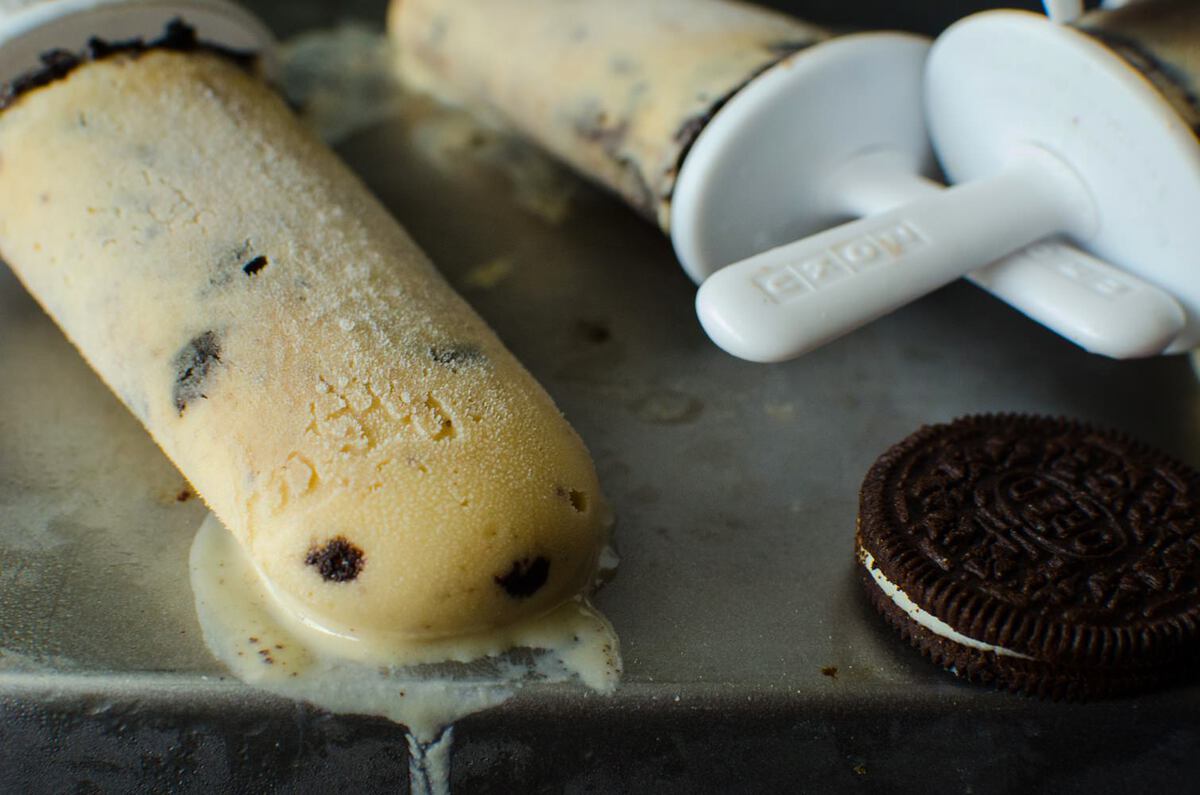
[0,50,607,638]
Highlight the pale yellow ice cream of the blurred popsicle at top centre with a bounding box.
[389,0,828,229]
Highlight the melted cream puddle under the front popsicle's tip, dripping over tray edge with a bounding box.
[188,514,622,793]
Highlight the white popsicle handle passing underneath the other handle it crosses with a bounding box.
[828,150,1187,359]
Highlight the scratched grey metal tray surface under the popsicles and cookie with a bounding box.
[0,4,1200,793]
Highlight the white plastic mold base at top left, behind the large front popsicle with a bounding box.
[0,0,274,87]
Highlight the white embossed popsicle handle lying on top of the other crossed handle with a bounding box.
[696,153,1093,361]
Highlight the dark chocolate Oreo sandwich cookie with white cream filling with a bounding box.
[856,414,1200,700]
